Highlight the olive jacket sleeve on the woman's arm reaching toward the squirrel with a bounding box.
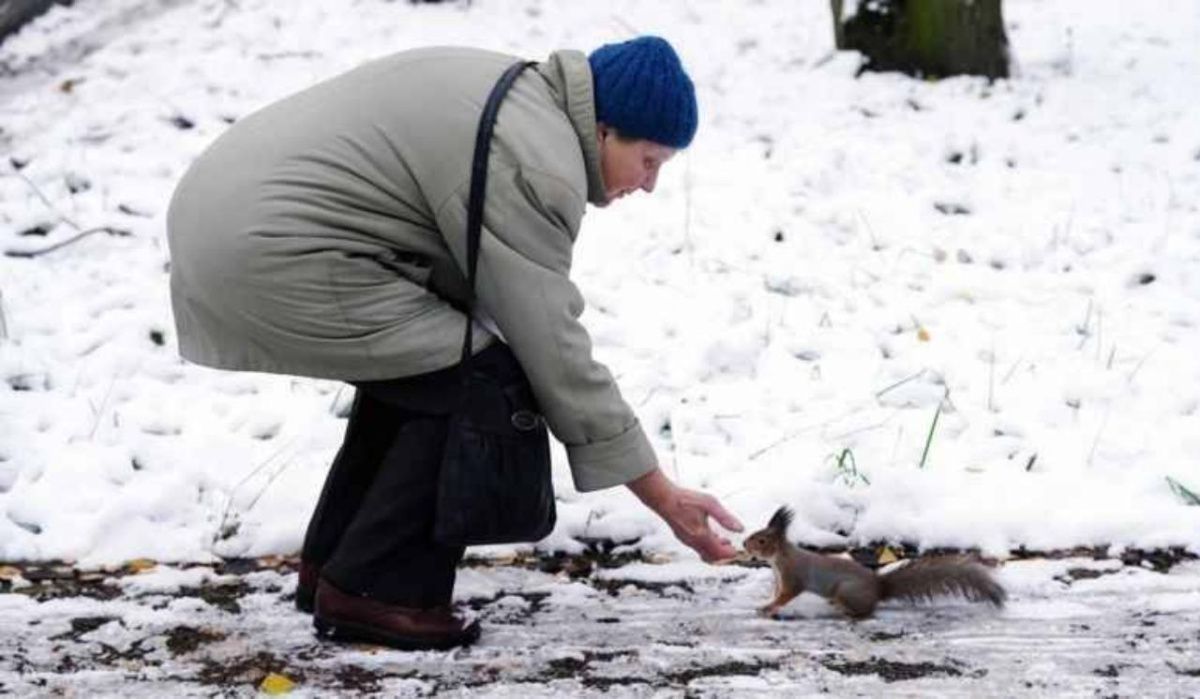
[437,166,658,491]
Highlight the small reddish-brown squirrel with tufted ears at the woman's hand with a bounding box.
[743,507,1007,619]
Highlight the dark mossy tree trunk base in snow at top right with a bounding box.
[830,0,1008,78]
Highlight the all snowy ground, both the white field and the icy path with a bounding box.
[0,0,1200,695]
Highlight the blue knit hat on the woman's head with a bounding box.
[588,36,696,148]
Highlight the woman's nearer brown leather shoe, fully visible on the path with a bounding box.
[312,579,479,651]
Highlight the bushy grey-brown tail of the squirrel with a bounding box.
[880,556,1008,607]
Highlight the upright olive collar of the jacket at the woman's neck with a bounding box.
[538,50,605,204]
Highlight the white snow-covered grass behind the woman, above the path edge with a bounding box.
[0,0,1200,566]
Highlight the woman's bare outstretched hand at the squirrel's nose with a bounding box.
[628,468,744,563]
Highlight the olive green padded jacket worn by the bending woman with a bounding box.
[167,48,656,490]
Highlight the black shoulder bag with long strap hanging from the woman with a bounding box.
[433,62,556,545]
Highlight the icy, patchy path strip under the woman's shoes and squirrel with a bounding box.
[0,558,1200,697]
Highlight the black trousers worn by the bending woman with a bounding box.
[301,346,480,609]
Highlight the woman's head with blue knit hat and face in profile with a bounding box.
[588,36,697,202]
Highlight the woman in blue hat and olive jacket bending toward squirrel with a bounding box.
[167,37,742,649]
